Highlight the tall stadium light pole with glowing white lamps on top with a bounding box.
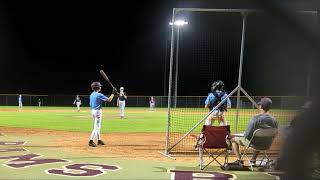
[169,20,188,108]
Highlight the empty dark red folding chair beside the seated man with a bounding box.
[196,125,232,170]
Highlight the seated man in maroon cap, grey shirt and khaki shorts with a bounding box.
[231,97,278,165]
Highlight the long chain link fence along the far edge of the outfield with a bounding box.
[0,94,305,109]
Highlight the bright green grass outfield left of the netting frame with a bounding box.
[0,106,167,132]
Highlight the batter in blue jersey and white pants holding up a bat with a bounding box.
[89,82,118,147]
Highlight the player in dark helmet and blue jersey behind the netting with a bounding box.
[205,80,231,126]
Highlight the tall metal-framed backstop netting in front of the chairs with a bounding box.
[166,9,310,153]
